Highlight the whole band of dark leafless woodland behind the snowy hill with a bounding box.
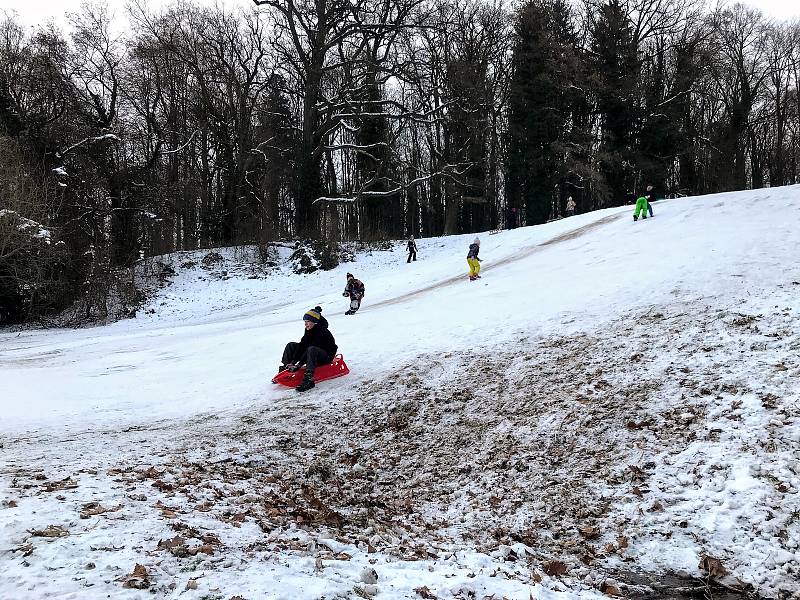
[0,0,800,323]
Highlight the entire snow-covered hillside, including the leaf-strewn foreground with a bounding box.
[0,186,800,600]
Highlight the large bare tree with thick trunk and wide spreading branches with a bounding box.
[254,0,434,235]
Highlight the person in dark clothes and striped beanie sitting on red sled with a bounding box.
[278,306,339,392]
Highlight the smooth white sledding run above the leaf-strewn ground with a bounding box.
[0,188,797,427]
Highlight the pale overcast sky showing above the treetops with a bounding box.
[0,0,800,25]
